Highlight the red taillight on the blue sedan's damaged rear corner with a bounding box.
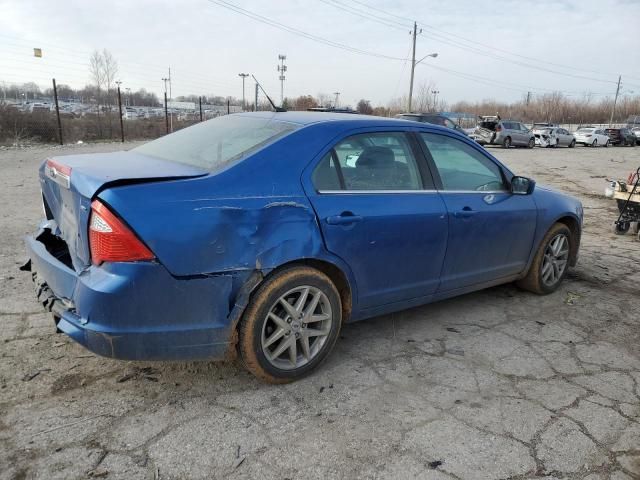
[89,200,154,265]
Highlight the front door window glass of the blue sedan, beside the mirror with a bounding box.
[420,133,507,192]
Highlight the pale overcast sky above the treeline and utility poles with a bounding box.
[0,0,640,105]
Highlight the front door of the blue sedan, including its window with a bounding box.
[420,133,537,291]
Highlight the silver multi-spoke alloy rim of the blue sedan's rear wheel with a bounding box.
[261,285,333,370]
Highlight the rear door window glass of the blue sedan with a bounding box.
[312,132,423,191]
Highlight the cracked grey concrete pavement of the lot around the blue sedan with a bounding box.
[0,144,640,480]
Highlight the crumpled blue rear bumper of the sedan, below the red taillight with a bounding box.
[25,228,241,360]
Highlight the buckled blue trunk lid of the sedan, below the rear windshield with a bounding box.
[40,152,208,271]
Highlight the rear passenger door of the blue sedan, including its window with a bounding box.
[303,131,448,309]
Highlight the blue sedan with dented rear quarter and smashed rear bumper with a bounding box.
[26,112,583,383]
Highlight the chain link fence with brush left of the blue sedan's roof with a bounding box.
[0,80,242,146]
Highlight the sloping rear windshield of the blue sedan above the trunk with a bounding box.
[133,115,298,171]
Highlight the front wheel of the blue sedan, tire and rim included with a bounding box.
[517,223,572,295]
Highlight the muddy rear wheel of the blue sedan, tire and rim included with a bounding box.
[238,266,342,383]
